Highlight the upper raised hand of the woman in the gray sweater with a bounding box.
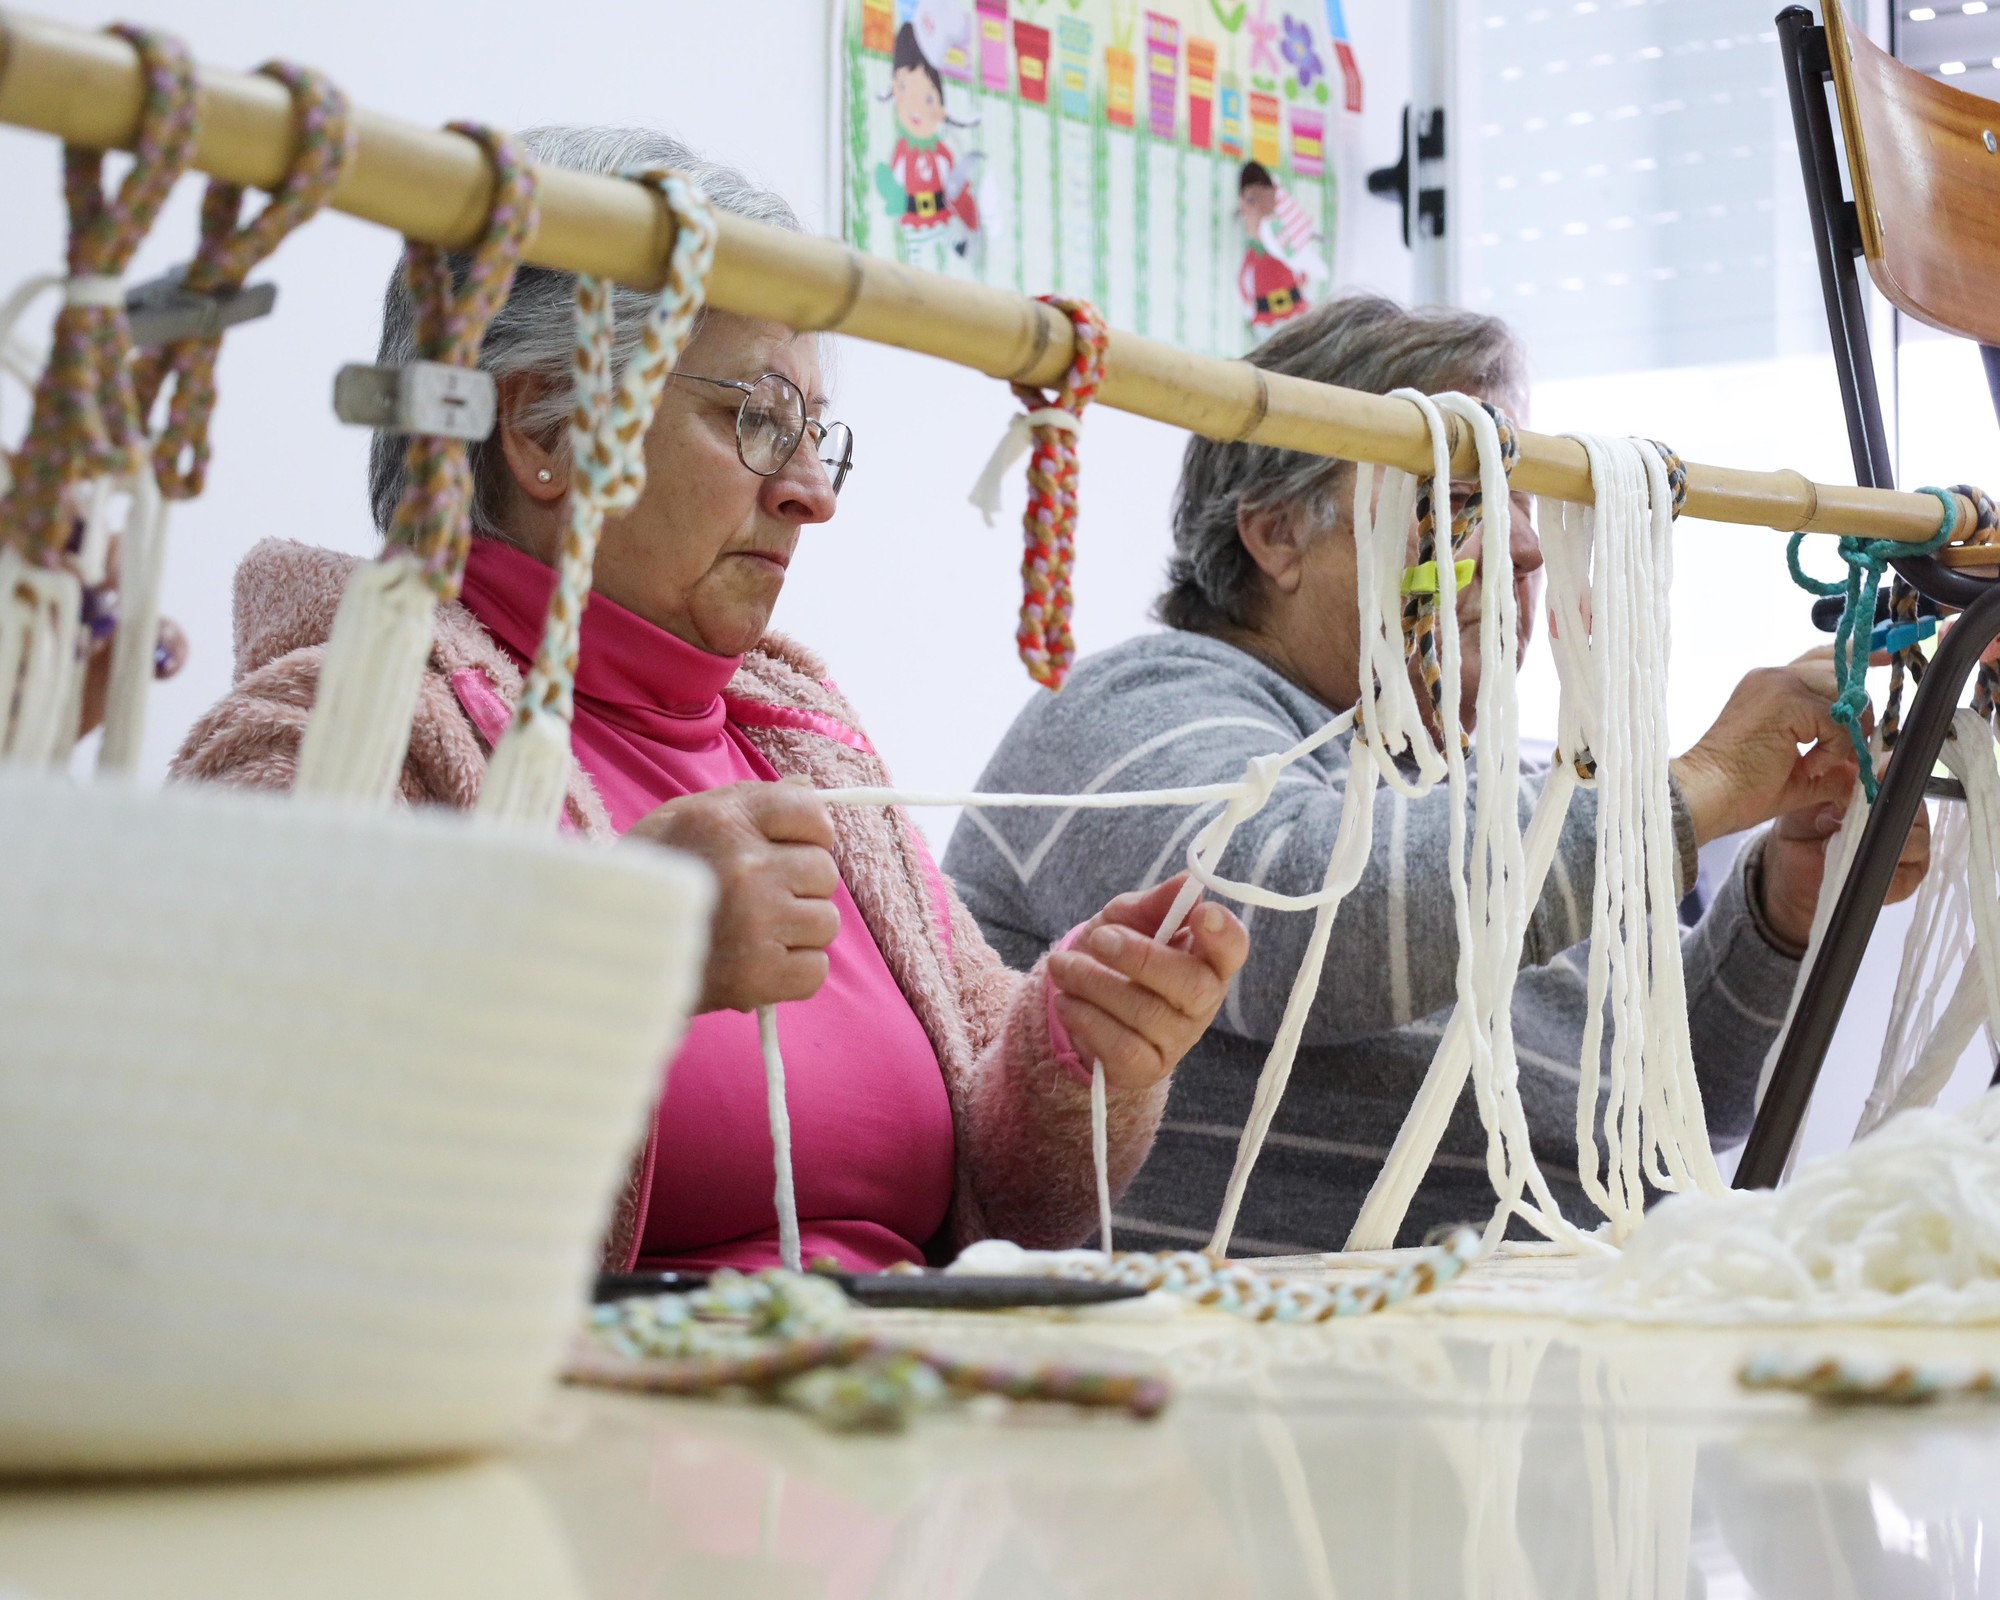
[1672,648,1856,844]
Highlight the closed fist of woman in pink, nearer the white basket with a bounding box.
[626,784,840,1012]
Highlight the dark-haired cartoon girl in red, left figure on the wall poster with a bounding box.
[876,0,982,256]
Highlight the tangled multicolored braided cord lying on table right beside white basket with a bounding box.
[566,1268,1170,1430]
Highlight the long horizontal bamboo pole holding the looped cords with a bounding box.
[0,12,1974,542]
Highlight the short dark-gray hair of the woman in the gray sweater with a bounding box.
[1154,294,1528,634]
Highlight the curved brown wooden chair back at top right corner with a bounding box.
[1824,0,2000,344]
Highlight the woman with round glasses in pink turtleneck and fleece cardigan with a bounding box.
[176,128,1248,1270]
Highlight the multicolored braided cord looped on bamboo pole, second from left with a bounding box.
[132,62,354,500]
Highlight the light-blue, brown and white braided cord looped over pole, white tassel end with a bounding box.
[474,168,716,832]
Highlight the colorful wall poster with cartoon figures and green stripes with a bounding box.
[840,0,1362,356]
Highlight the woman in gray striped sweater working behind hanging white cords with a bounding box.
[944,296,1928,1254]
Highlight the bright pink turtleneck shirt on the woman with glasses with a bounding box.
[460,540,952,1272]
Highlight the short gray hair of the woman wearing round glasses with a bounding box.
[368,126,804,538]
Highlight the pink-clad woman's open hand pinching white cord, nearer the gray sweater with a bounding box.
[1048,874,1250,1088]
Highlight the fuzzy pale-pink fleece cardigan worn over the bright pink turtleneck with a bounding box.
[172,540,1166,1264]
